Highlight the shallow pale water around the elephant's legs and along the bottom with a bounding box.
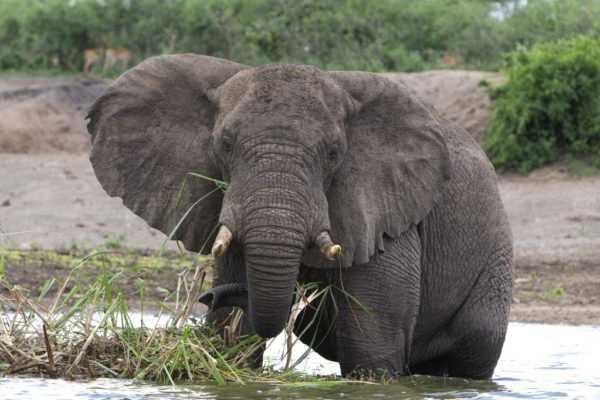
[0,324,600,400]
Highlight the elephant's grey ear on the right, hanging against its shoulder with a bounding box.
[327,72,451,267]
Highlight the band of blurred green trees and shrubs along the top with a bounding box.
[0,0,600,73]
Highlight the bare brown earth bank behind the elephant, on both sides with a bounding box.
[0,71,600,324]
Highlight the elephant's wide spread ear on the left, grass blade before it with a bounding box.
[88,54,247,252]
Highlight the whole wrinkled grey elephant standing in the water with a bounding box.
[88,54,512,378]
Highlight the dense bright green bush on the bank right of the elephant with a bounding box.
[484,36,600,173]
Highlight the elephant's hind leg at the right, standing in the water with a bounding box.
[448,264,512,379]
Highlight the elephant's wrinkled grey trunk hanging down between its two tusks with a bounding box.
[240,174,320,337]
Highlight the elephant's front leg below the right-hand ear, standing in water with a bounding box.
[335,227,421,376]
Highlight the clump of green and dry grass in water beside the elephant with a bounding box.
[0,252,360,384]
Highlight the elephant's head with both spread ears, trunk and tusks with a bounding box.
[88,54,450,337]
